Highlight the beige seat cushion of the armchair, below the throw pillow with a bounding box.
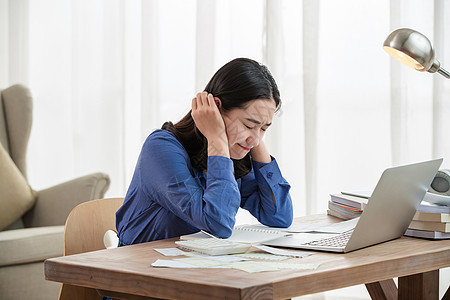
[0,225,64,266]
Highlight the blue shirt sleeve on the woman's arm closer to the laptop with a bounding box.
[241,157,293,227]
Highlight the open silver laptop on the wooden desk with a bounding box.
[264,158,442,253]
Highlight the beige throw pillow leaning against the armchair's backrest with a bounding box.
[0,144,36,230]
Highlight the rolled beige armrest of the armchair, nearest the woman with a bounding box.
[23,173,111,227]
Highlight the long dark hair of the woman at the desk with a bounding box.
[162,58,281,178]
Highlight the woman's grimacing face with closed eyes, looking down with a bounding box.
[222,99,276,159]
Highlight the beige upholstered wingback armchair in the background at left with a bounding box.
[0,85,110,300]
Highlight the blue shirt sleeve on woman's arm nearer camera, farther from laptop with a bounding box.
[137,132,240,237]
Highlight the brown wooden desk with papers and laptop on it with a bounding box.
[45,216,450,299]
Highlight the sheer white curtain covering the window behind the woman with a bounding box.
[0,0,450,292]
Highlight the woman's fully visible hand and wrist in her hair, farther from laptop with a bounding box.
[191,92,230,157]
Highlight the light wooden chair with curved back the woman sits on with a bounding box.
[59,198,124,300]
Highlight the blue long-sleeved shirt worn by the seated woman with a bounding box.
[116,130,292,244]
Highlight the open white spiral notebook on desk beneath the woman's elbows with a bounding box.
[180,225,290,244]
